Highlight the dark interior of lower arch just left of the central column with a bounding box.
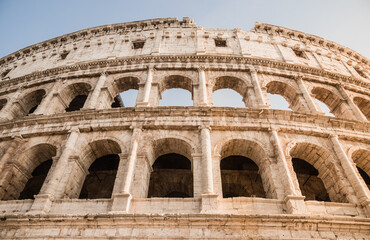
[148,153,193,198]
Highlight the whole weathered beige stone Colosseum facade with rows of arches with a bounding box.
[0,17,370,239]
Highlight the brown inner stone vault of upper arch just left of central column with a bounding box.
[158,74,194,104]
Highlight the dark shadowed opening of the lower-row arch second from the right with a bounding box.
[292,158,330,202]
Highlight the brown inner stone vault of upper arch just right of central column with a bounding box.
[212,76,251,106]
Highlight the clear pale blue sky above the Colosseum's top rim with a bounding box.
[0,0,370,111]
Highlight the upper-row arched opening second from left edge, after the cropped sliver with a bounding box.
[11,89,46,118]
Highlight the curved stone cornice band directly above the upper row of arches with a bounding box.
[0,55,370,96]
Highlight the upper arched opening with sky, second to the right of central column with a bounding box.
[266,81,305,112]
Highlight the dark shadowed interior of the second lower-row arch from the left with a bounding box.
[79,154,120,199]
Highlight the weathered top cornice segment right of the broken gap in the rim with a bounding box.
[251,22,370,65]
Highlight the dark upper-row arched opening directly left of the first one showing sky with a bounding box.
[59,83,91,112]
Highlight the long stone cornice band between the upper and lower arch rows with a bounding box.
[0,107,370,143]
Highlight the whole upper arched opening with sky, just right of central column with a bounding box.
[212,76,252,107]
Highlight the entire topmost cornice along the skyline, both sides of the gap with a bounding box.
[0,17,370,69]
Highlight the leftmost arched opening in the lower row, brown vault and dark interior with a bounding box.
[0,143,57,200]
